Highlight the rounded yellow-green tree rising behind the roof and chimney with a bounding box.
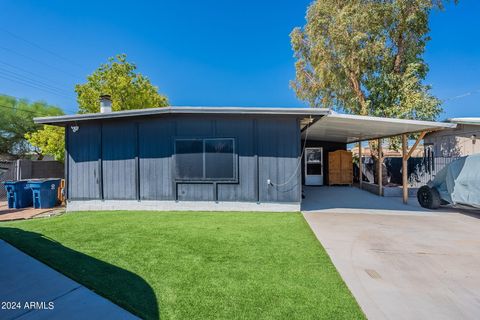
[75,54,168,113]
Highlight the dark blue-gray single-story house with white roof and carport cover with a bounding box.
[35,97,454,211]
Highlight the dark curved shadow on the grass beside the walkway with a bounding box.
[0,227,159,319]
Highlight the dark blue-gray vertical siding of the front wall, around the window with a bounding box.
[67,115,301,202]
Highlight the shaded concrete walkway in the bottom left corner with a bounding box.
[0,240,138,319]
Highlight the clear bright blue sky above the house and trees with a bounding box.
[0,0,480,119]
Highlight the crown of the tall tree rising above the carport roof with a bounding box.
[291,0,456,120]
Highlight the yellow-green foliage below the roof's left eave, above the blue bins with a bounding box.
[25,125,65,162]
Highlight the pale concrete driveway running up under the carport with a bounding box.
[304,188,480,319]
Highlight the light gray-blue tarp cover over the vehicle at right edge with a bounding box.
[429,154,480,208]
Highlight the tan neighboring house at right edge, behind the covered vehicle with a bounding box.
[424,118,480,157]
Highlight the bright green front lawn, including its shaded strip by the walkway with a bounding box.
[0,212,365,319]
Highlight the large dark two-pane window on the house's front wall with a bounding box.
[175,138,237,181]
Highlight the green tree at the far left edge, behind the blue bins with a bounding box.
[0,95,63,158]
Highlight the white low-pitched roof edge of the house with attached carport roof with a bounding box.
[34,107,456,143]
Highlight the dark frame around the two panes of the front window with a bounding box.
[172,137,239,183]
